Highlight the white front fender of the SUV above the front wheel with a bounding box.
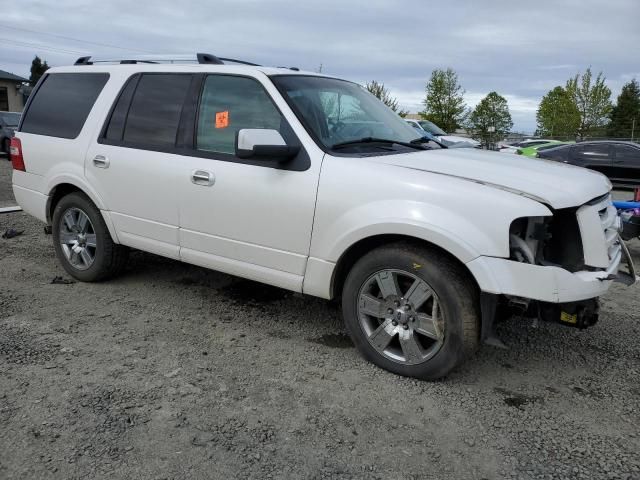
[303,156,552,298]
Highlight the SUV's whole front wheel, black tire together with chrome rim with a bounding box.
[342,243,480,380]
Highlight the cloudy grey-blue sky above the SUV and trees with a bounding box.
[0,0,640,133]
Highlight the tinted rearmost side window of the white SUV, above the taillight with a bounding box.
[20,73,109,138]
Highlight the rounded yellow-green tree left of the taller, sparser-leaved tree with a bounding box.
[536,87,580,138]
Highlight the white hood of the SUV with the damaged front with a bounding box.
[370,148,611,209]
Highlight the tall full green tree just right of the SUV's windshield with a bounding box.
[420,68,467,132]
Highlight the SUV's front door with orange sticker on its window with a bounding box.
[177,74,323,291]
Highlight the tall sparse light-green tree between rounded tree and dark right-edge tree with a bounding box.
[565,67,612,139]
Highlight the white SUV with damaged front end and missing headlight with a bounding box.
[11,54,635,379]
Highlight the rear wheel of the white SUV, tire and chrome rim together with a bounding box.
[52,192,129,282]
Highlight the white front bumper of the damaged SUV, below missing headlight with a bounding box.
[467,240,637,303]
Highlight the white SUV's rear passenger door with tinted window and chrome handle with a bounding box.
[85,73,194,259]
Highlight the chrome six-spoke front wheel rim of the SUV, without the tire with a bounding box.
[358,269,445,365]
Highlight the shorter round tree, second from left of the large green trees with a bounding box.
[467,92,513,148]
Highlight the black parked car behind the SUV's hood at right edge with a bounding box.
[538,140,640,186]
